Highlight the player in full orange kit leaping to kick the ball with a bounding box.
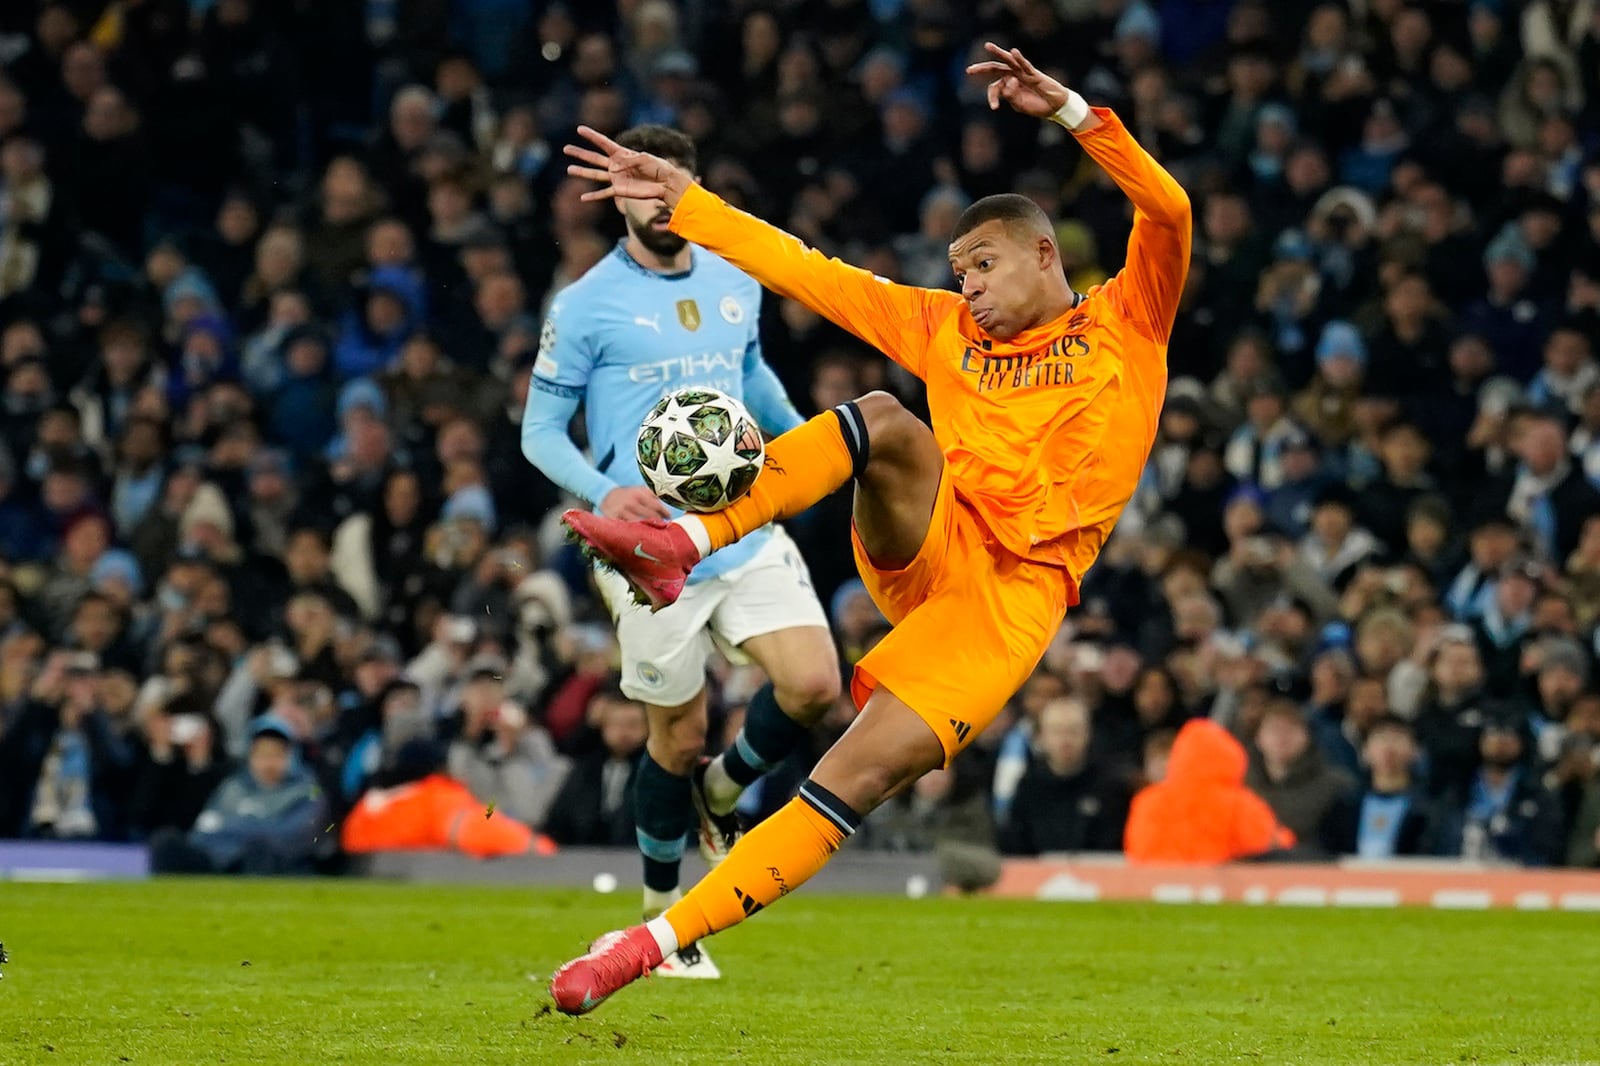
[550,43,1190,1015]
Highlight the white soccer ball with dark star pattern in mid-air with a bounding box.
[637,389,766,514]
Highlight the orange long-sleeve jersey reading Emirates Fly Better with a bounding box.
[672,109,1190,583]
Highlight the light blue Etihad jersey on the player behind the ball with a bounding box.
[522,243,802,583]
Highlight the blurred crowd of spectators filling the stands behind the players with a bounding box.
[0,0,1600,880]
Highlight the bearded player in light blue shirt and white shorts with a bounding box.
[522,126,840,976]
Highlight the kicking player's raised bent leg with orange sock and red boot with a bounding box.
[562,392,944,610]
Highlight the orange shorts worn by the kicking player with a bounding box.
[850,472,1074,767]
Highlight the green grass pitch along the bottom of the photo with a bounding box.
[0,880,1600,1066]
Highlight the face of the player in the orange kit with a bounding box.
[950,221,1061,341]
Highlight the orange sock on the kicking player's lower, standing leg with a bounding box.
[666,781,861,944]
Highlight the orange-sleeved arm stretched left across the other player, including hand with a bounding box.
[565,126,960,378]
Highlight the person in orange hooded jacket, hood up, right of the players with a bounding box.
[1125,719,1294,863]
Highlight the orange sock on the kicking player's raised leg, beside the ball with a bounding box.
[700,403,866,550]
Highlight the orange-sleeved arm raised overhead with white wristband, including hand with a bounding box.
[966,43,1194,344]
